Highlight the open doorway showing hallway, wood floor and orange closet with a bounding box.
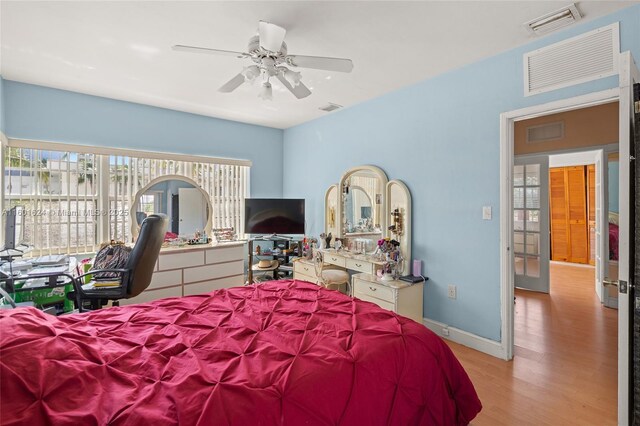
[512,100,619,424]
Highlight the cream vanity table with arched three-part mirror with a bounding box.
[316,165,424,323]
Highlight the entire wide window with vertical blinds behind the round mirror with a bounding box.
[2,141,249,255]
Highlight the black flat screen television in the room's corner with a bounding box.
[244,198,304,234]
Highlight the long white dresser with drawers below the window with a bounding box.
[120,241,245,305]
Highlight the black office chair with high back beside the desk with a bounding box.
[69,214,167,312]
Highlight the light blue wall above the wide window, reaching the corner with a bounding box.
[4,80,283,197]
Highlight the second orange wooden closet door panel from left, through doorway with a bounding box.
[566,166,589,263]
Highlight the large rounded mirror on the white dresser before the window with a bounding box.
[130,175,213,238]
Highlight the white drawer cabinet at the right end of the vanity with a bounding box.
[352,274,424,324]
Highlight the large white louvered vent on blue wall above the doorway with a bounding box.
[524,22,620,96]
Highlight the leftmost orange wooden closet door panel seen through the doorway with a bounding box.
[549,167,570,262]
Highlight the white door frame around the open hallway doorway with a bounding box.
[500,87,620,360]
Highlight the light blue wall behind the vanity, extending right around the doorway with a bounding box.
[284,6,640,340]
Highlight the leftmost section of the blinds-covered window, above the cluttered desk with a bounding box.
[3,147,98,253]
